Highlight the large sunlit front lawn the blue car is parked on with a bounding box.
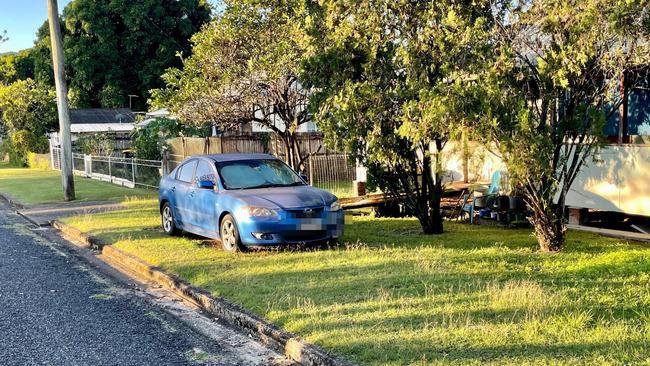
[66,201,650,365]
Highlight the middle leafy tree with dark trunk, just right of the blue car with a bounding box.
[305,0,491,234]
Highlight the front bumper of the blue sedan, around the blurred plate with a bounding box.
[235,210,345,246]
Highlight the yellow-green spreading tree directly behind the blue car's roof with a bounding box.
[153,0,309,169]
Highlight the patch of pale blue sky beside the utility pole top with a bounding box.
[0,0,71,53]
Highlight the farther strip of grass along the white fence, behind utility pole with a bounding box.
[0,164,156,205]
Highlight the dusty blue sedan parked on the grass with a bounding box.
[159,154,344,252]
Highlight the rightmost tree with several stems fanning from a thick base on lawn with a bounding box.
[475,0,650,251]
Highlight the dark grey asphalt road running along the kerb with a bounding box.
[0,203,286,366]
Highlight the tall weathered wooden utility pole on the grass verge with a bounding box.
[47,0,75,201]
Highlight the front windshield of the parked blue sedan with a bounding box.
[217,159,305,189]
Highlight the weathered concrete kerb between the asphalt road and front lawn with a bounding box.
[52,220,354,366]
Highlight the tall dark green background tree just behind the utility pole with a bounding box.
[35,0,211,108]
